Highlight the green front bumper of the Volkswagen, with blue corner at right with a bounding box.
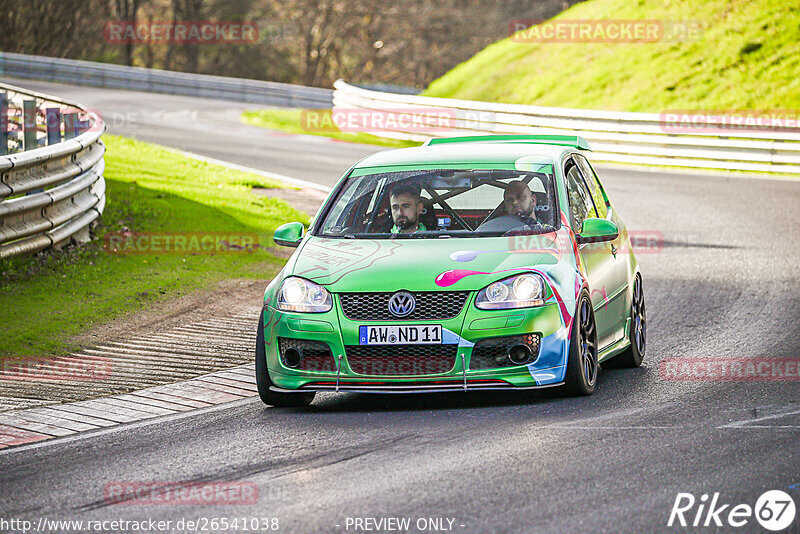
[263,296,568,393]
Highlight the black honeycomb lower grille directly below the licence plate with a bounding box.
[345,345,458,376]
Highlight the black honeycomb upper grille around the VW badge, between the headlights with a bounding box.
[339,291,469,321]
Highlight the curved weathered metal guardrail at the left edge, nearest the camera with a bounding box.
[0,84,106,258]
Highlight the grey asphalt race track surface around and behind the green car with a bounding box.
[0,82,800,533]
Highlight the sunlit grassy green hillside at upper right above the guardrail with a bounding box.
[424,0,800,110]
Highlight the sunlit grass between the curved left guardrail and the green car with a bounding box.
[0,135,308,357]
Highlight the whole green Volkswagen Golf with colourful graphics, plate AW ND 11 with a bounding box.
[255,135,646,406]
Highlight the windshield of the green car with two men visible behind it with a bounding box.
[317,163,559,239]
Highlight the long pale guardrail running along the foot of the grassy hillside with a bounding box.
[333,80,800,174]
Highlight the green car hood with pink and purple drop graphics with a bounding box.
[286,231,569,293]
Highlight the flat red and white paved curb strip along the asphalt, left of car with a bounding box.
[0,364,258,449]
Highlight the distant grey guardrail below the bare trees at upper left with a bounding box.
[0,52,333,109]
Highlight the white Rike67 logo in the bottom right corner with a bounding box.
[667,490,796,532]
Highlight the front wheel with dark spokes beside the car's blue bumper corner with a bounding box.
[564,293,598,396]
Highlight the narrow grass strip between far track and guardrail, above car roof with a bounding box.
[242,109,422,148]
